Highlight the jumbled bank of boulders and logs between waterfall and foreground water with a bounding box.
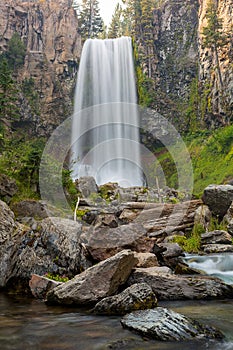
[0,179,233,340]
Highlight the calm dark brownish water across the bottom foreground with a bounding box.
[0,294,233,350]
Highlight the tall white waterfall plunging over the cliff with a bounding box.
[70,37,143,187]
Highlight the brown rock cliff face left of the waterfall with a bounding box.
[0,0,81,135]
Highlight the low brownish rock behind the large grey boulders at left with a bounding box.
[12,199,48,220]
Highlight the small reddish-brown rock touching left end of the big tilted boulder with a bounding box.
[29,274,61,299]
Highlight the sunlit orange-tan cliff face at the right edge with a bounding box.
[198,0,233,125]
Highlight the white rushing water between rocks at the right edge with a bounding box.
[184,253,233,284]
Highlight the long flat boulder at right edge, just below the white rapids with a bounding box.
[127,268,233,300]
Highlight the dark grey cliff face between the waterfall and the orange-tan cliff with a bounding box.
[139,0,199,127]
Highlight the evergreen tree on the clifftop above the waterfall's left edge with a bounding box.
[78,0,104,41]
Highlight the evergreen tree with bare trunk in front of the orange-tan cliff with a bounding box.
[202,0,229,90]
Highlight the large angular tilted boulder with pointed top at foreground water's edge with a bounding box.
[47,250,137,306]
